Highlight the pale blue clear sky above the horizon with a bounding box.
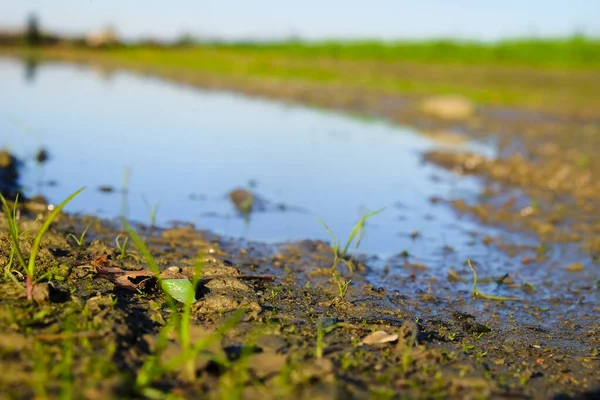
[0,0,600,40]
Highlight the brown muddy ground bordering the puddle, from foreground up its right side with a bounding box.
[0,51,600,399]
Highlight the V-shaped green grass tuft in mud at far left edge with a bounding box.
[0,187,85,300]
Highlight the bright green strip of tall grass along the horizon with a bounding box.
[191,36,600,68]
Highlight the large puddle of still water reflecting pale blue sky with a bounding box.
[5,59,592,304]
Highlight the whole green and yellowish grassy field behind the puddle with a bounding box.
[8,37,600,117]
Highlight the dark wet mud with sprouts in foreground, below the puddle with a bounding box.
[0,192,600,398]
